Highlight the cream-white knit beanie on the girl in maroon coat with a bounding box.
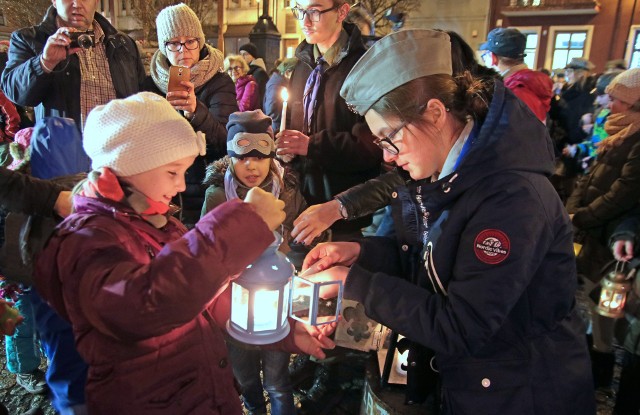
[82,92,206,176]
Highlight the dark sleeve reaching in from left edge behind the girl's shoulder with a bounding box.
[0,167,62,216]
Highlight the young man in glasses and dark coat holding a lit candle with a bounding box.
[276,0,382,244]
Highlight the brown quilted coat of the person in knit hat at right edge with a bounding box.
[567,131,640,282]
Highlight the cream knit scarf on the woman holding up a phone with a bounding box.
[150,45,224,94]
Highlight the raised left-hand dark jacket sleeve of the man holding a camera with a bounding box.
[0,28,55,107]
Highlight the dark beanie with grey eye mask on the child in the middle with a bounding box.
[227,110,276,158]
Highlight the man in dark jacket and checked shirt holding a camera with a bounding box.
[1,0,145,130]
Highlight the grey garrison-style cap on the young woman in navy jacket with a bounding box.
[340,29,452,115]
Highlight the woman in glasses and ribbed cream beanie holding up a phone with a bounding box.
[144,3,238,228]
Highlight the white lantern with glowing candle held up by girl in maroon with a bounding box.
[227,232,295,345]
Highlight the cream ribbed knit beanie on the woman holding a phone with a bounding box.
[156,3,205,55]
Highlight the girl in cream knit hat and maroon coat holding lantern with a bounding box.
[36,92,332,415]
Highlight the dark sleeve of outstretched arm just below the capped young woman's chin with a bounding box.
[336,170,405,219]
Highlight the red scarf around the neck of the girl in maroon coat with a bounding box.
[79,167,175,228]
